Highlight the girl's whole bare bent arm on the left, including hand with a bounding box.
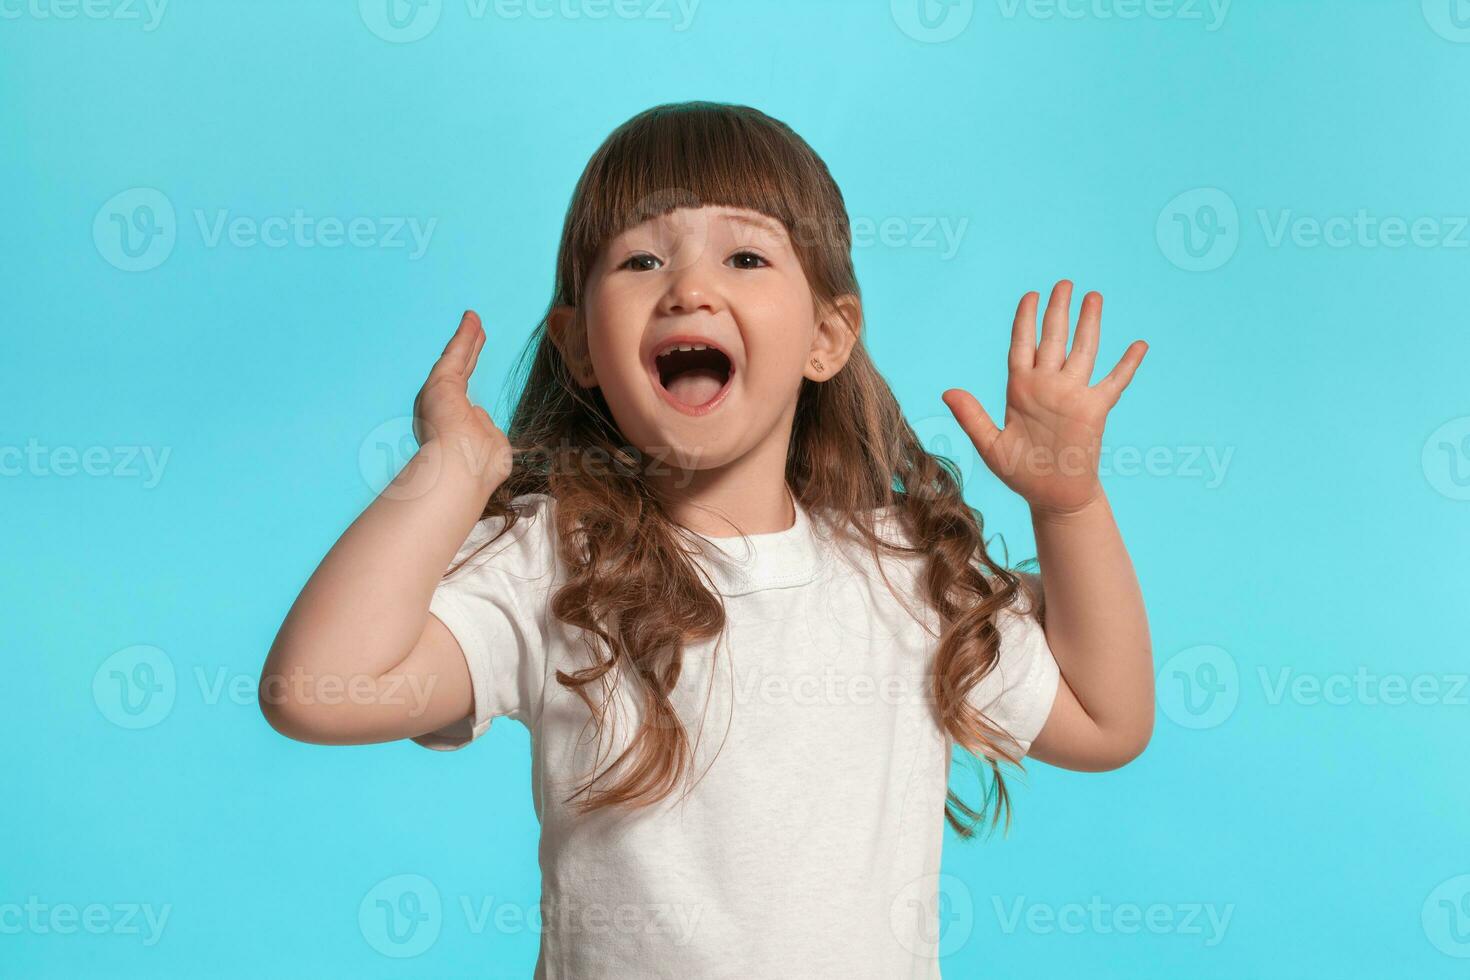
[259,311,512,745]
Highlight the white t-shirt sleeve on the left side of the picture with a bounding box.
[413,495,556,749]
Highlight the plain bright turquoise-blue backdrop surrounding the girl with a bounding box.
[0,0,1470,979]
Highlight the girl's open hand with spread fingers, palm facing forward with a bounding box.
[944,279,1148,516]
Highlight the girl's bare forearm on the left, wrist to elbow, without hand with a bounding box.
[262,438,497,685]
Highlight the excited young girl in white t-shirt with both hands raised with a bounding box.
[260,103,1154,980]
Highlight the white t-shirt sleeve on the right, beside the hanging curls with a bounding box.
[970,573,1061,755]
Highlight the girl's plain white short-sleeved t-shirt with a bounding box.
[415,494,1060,980]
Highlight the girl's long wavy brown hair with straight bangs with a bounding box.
[452,101,1040,837]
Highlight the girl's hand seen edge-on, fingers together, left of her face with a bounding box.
[413,310,510,461]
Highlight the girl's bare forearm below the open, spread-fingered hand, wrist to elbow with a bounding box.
[1032,495,1154,743]
